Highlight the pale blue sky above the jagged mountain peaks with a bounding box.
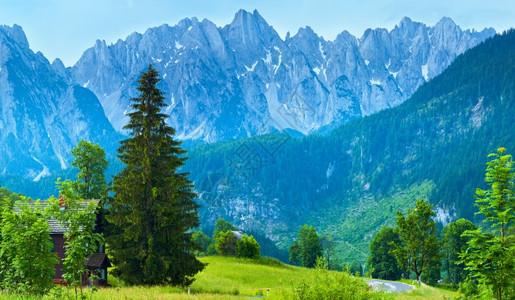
[0,0,515,66]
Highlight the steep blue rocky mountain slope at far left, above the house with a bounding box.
[0,25,119,181]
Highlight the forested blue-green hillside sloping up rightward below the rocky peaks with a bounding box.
[186,30,515,261]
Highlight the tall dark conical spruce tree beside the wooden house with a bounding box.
[107,65,204,285]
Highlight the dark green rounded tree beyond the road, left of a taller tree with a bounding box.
[368,226,404,280]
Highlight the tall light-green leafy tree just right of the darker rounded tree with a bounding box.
[390,199,442,280]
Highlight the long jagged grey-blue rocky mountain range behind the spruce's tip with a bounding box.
[69,10,495,142]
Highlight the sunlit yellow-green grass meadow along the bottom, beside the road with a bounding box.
[0,256,456,300]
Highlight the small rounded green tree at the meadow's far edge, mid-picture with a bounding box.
[290,224,322,268]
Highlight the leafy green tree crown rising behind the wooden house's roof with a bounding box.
[72,140,108,199]
